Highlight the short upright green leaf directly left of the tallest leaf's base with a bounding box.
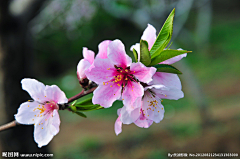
[140,40,151,66]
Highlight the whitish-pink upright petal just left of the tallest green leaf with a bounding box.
[141,24,157,50]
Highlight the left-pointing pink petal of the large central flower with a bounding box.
[86,58,116,84]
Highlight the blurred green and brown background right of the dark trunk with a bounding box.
[0,0,240,159]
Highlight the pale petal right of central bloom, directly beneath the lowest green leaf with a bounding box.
[152,72,182,90]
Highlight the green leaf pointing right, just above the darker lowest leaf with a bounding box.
[149,49,191,66]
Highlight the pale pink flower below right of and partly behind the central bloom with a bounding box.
[115,72,184,135]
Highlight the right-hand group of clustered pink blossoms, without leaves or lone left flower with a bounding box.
[77,24,187,135]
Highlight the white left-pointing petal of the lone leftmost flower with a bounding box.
[15,101,40,124]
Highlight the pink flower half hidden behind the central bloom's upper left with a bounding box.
[77,40,111,82]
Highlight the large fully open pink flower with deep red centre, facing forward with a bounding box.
[86,40,156,109]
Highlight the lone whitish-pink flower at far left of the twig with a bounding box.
[15,78,68,147]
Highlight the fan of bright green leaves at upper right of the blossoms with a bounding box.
[133,8,191,74]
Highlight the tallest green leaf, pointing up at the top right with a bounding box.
[150,8,175,58]
